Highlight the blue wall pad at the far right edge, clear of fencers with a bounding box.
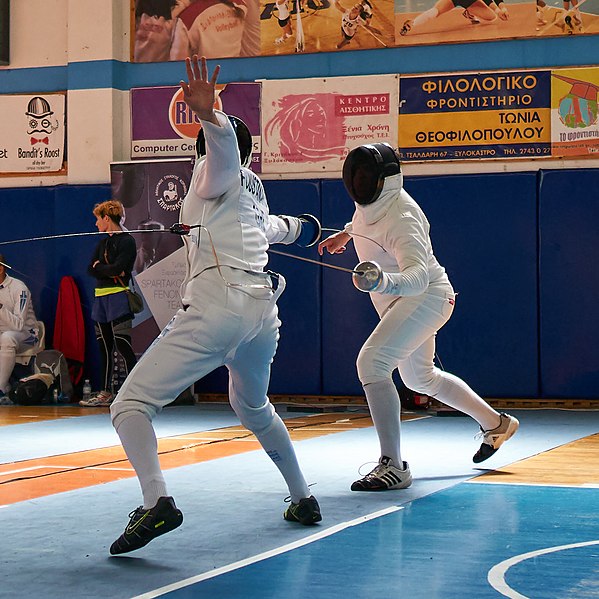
[539,169,599,398]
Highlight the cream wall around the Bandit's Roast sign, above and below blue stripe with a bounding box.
[0,0,131,187]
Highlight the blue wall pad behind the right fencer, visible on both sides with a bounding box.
[323,173,538,397]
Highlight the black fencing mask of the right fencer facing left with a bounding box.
[343,143,401,205]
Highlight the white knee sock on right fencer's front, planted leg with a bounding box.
[364,379,403,468]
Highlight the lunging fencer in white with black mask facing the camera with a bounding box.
[318,143,518,491]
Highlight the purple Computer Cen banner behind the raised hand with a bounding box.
[131,83,260,173]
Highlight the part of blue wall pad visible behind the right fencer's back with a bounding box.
[405,173,539,397]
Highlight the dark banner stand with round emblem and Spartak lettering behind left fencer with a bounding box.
[110,159,192,353]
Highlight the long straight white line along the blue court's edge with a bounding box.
[132,505,404,599]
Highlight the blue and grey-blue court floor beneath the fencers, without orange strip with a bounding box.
[0,407,599,599]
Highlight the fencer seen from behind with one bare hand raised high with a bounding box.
[110,56,321,554]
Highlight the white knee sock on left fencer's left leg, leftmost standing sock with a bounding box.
[116,412,168,509]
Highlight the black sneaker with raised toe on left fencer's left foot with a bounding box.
[110,497,183,555]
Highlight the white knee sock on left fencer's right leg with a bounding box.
[256,414,310,503]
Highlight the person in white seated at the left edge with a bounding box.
[0,255,39,404]
